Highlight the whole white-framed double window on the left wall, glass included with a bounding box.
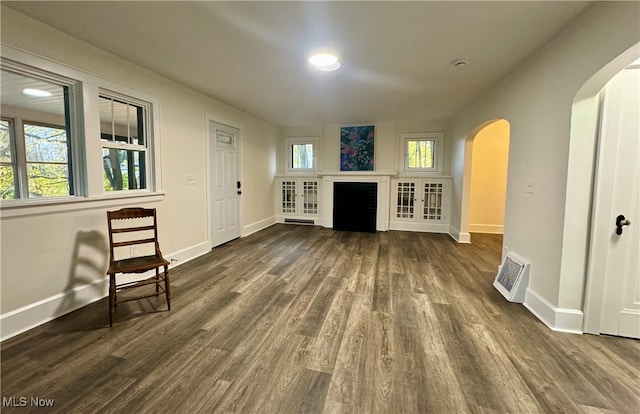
[0,51,161,213]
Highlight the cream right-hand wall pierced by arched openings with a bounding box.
[451,2,640,326]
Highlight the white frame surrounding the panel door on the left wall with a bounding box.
[204,113,244,249]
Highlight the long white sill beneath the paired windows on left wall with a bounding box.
[0,192,164,219]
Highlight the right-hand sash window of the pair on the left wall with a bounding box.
[100,95,147,191]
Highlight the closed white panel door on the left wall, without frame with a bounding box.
[209,121,242,247]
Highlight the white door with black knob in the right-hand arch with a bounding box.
[591,66,640,338]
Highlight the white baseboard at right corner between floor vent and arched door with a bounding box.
[524,288,584,334]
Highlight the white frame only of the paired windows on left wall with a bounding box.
[0,45,164,218]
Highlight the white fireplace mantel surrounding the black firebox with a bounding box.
[318,171,398,231]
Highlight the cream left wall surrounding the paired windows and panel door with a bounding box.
[0,7,281,338]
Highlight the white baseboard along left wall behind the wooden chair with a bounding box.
[0,241,211,341]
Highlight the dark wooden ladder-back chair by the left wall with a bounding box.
[107,207,171,326]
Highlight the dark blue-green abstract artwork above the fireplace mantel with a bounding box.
[340,125,375,171]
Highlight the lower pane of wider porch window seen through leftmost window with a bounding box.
[27,163,69,198]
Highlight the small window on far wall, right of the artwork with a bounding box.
[402,133,442,172]
